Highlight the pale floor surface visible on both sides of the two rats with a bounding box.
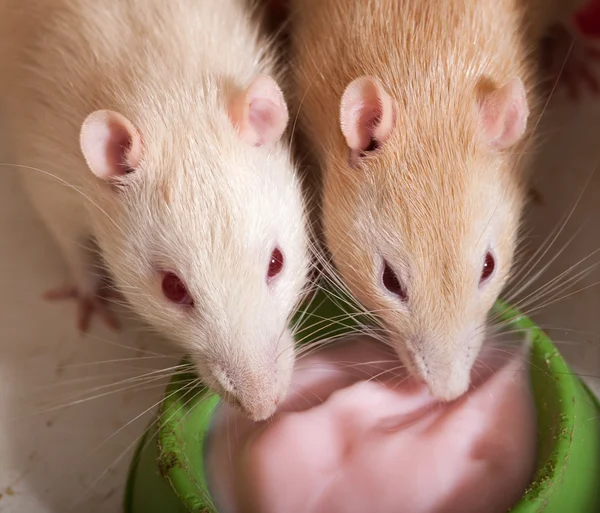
[0,41,600,513]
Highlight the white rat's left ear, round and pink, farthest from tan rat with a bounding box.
[80,110,142,180]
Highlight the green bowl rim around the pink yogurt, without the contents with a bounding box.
[125,293,600,513]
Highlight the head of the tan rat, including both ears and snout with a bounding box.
[323,77,528,400]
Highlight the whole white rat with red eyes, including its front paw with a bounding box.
[0,0,309,420]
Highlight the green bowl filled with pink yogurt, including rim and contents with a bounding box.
[126,296,600,513]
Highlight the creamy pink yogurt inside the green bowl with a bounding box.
[207,337,536,513]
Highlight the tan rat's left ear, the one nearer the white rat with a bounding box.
[340,76,396,151]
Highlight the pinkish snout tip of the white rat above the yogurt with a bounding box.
[212,365,282,422]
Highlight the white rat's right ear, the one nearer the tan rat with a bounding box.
[229,75,289,146]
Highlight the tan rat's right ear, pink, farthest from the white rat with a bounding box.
[479,78,529,150]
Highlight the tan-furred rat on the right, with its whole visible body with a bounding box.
[290,0,559,400]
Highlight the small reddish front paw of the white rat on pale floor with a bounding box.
[43,285,119,333]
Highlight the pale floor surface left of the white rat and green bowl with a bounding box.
[0,126,179,513]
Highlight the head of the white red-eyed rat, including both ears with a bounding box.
[81,76,308,420]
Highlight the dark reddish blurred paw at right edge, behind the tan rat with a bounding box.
[542,25,600,101]
